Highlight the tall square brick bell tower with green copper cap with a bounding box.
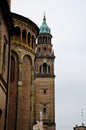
[34,15,55,130]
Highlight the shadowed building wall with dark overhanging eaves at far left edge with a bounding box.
[0,0,13,130]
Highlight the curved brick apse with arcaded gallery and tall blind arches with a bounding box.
[8,14,38,130]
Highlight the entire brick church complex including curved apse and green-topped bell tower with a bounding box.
[0,0,55,130]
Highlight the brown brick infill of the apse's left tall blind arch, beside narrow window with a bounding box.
[7,52,18,130]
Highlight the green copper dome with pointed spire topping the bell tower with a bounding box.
[39,15,51,34]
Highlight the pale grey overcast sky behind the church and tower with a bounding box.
[11,0,86,130]
